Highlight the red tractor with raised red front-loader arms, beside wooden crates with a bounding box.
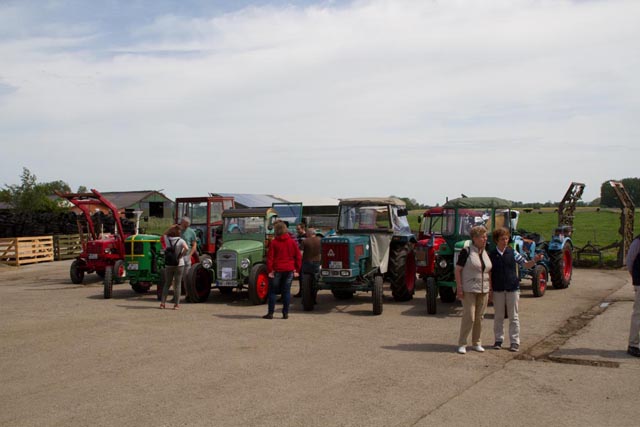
[56,189,136,284]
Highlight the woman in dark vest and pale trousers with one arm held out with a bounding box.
[489,227,543,351]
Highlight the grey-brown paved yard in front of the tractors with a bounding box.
[0,261,640,426]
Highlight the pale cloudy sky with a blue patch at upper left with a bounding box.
[0,0,640,204]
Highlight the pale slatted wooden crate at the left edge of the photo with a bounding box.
[0,236,53,266]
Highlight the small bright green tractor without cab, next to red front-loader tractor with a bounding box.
[104,234,164,299]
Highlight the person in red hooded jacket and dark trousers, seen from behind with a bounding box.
[262,221,302,319]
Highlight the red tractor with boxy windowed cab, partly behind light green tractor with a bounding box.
[175,196,235,274]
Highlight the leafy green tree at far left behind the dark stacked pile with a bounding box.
[0,167,71,212]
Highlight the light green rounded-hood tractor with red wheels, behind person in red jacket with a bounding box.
[186,208,277,304]
